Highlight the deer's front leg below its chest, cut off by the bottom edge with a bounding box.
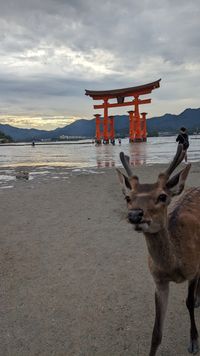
[149,282,169,356]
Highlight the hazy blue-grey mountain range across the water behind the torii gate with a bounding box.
[0,108,200,141]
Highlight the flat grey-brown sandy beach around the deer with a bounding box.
[0,163,200,356]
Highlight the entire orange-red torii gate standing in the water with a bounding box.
[85,79,161,143]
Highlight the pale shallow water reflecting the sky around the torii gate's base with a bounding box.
[0,136,200,183]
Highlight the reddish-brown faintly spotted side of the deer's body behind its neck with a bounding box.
[168,188,200,280]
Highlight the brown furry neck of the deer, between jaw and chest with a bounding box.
[145,227,176,271]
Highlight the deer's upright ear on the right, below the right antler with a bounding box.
[166,164,191,196]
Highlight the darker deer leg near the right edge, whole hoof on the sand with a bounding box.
[186,279,199,355]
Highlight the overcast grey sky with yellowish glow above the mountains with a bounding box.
[0,0,200,130]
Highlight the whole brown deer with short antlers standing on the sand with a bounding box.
[116,144,200,356]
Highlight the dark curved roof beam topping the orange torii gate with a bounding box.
[85,79,161,99]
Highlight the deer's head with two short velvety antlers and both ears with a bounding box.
[117,145,191,233]
